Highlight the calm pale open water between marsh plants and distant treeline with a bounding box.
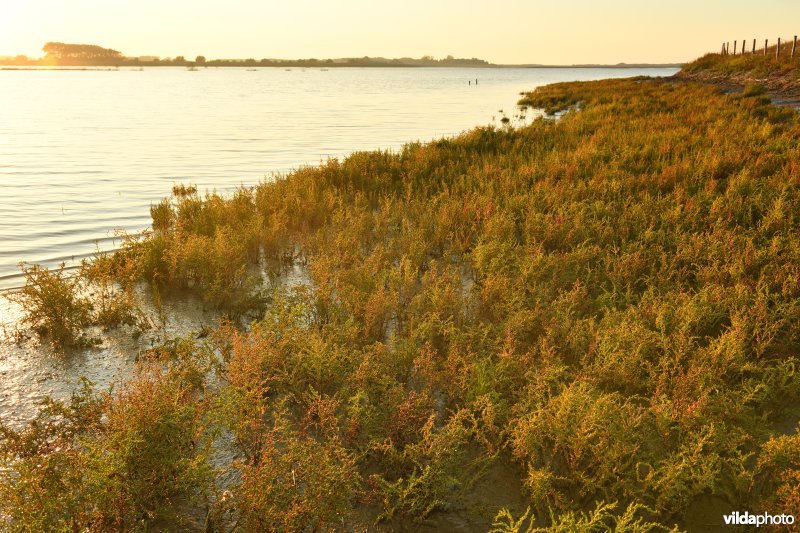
[0,68,675,288]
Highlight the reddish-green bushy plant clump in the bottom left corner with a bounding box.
[0,340,212,531]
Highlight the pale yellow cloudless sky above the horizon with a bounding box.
[0,0,800,64]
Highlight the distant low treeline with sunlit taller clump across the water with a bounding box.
[0,42,492,67]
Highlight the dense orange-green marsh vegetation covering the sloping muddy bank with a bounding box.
[6,71,800,531]
